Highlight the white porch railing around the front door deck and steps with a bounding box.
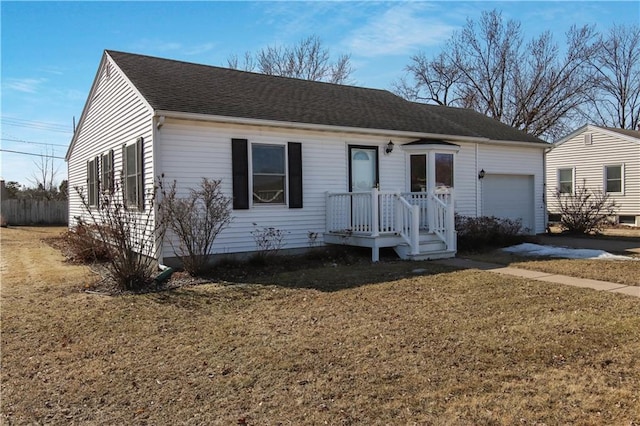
[326,188,456,254]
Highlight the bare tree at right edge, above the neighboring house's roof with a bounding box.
[586,25,640,129]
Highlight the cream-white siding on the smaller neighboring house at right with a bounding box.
[546,126,640,216]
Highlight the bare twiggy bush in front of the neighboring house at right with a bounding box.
[555,185,617,234]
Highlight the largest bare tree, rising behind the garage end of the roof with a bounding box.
[395,10,598,137]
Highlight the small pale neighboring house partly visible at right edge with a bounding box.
[546,125,640,226]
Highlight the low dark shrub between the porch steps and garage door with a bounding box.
[455,215,526,251]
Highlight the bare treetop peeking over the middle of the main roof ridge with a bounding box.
[227,35,353,84]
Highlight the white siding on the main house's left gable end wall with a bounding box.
[68,58,154,230]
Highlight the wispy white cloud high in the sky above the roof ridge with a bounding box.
[343,3,457,57]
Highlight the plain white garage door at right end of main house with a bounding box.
[481,174,535,233]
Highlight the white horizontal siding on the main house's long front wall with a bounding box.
[156,119,544,257]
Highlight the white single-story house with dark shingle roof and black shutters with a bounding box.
[66,51,548,263]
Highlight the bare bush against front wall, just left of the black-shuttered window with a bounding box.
[158,178,231,275]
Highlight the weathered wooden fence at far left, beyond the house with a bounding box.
[2,199,69,226]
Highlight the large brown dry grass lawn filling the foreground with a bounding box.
[0,229,640,425]
